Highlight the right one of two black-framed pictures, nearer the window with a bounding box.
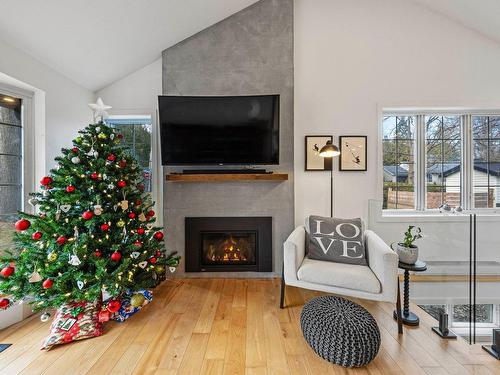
[339,135,368,172]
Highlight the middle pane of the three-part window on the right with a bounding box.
[425,116,462,209]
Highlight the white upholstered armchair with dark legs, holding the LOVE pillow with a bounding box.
[280,226,401,331]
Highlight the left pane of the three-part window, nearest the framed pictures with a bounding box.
[382,116,415,209]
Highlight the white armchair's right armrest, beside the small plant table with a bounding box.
[365,230,398,302]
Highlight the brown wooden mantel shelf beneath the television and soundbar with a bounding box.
[167,173,288,182]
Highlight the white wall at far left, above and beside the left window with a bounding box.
[0,36,94,172]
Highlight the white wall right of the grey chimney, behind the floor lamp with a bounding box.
[294,0,500,223]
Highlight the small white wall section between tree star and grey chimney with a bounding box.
[97,57,162,110]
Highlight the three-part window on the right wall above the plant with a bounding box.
[382,111,500,211]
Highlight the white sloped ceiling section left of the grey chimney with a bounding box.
[0,0,256,91]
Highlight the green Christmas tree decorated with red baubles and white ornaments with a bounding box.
[0,100,179,311]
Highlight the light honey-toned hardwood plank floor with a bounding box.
[0,279,500,375]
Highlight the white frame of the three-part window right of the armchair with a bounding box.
[377,107,500,216]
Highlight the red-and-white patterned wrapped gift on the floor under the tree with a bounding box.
[42,301,104,350]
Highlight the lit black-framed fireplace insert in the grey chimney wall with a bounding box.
[185,217,272,272]
